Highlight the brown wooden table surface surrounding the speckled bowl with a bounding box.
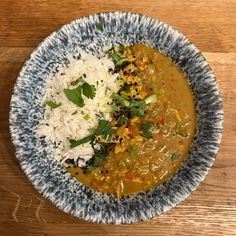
[0,0,236,236]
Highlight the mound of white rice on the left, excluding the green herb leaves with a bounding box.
[37,50,118,167]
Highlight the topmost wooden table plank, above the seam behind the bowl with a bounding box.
[0,0,236,52]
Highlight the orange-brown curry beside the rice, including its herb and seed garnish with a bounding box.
[67,44,196,198]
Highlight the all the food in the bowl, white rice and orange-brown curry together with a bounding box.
[38,44,196,198]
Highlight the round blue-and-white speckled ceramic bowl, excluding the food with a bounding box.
[10,12,223,224]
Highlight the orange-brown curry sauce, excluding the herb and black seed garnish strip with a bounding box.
[67,44,196,198]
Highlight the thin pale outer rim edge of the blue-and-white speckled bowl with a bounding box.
[9,11,224,224]
